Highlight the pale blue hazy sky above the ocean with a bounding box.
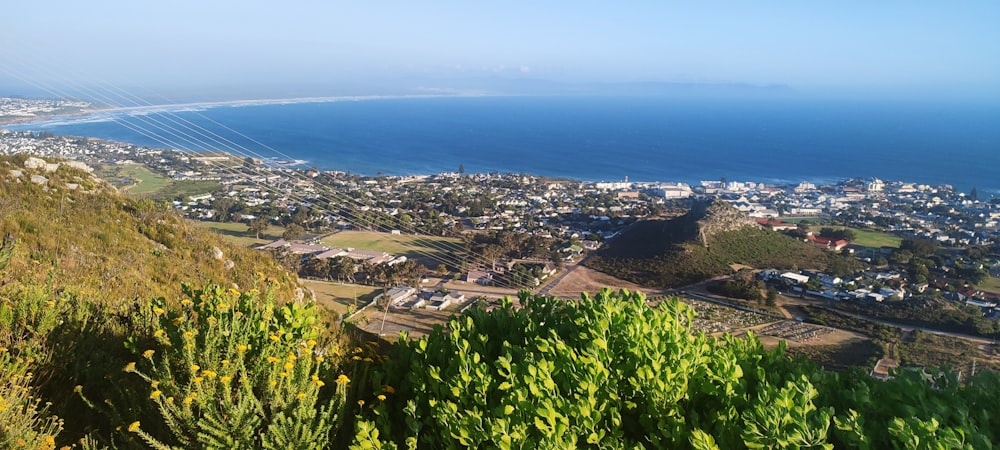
[0,0,1000,98]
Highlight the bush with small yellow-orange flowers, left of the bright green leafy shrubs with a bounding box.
[125,285,349,449]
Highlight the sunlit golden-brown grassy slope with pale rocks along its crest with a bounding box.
[0,156,294,303]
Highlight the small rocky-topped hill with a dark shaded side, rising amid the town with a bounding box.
[586,200,860,288]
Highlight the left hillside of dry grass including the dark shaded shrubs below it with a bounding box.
[0,156,312,448]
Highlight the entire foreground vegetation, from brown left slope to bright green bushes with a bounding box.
[0,158,1000,449]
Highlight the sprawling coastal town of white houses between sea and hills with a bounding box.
[0,110,1000,374]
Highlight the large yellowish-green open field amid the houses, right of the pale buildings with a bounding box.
[321,230,463,267]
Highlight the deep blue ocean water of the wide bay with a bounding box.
[13,97,1000,193]
